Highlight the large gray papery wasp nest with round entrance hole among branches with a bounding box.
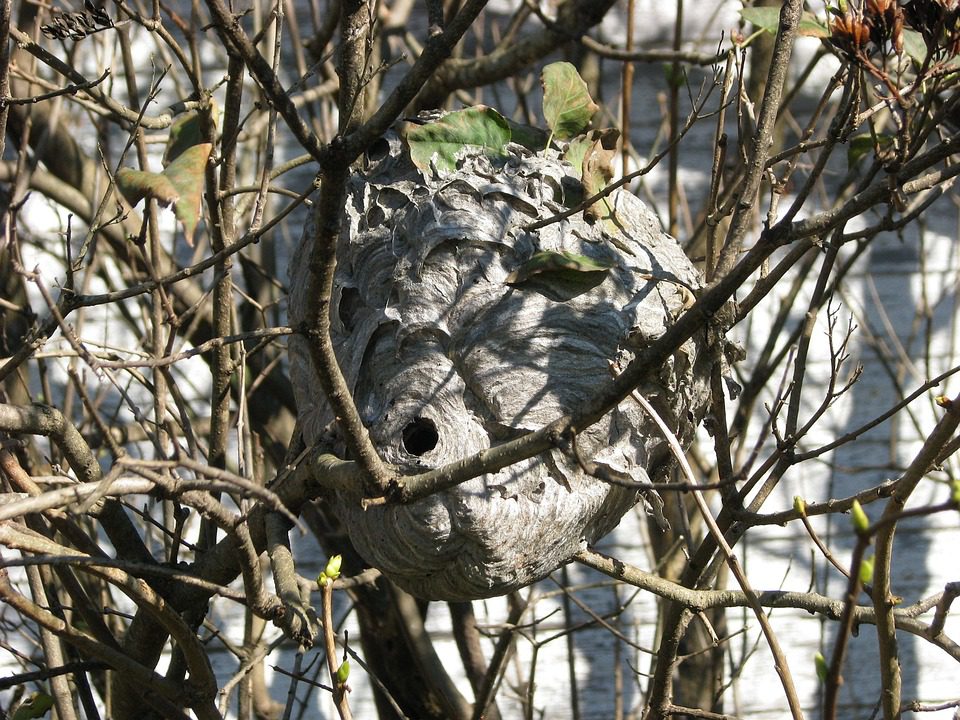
[290,136,708,600]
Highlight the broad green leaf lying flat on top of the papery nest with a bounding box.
[406,105,512,173]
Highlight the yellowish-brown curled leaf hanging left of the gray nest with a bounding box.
[117,143,213,245]
